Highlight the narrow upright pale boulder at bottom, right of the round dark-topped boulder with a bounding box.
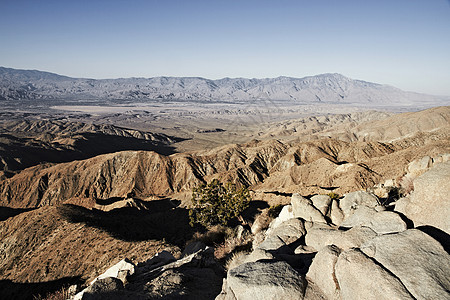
[306,245,341,299]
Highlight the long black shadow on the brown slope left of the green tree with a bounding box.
[58,199,193,246]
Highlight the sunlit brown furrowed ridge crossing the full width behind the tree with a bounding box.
[0,122,450,208]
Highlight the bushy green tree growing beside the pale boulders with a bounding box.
[189,179,250,227]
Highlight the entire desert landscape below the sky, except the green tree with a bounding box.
[0,67,450,299]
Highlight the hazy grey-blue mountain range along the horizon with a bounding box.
[0,67,449,105]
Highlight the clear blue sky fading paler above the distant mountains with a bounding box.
[0,0,450,95]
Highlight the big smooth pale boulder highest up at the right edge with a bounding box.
[395,162,450,234]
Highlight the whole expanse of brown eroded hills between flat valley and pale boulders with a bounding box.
[0,107,450,299]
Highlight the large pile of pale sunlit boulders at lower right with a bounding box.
[220,176,450,299]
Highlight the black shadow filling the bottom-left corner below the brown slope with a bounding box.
[0,277,82,300]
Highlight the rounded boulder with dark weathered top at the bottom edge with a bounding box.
[227,260,306,300]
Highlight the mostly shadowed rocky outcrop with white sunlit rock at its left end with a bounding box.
[71,248,222,300]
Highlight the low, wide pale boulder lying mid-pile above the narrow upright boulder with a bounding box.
[305,224,377,251]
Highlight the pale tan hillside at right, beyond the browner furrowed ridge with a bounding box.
[259,106,450,142]
